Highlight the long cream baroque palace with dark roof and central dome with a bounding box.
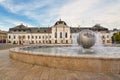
[7,19,112,45]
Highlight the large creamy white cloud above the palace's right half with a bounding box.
[55,0,120,29]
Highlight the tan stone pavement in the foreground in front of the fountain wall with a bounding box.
[0,50,120,80]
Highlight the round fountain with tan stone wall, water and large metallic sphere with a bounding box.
[10,30,120,73]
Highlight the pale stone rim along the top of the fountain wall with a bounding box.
[9,46,120,60]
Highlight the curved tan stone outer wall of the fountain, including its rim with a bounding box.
[10,45,120,74]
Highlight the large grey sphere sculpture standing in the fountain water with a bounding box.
[77,30,96,49]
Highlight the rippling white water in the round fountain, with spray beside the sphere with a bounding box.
[21,29,120,57]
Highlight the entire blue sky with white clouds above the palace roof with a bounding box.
[0,0,120,31]
